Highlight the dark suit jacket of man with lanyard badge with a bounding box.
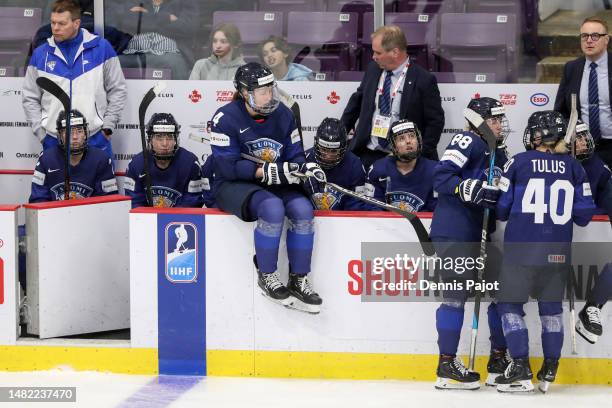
[340,61,444,160]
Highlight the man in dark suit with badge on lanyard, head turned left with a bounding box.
[340,26,444,168]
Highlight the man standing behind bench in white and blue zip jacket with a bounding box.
[23,0,127,157]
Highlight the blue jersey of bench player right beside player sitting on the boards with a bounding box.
[304,149,370,211]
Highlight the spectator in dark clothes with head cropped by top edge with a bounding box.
[109,0,198,79]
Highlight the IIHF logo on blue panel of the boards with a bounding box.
[165,222,198,283]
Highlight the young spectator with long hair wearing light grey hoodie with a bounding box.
[189,23,246,81]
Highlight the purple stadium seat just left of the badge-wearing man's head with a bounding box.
[287,11,358,72]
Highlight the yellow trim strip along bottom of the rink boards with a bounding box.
[0,346,612,385]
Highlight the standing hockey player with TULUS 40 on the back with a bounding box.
[496,111,595,392]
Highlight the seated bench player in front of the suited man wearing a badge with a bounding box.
[366,119,437,212]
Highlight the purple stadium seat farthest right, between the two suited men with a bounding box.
[435,13,517,82]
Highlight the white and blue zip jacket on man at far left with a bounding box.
[22,28,127,141]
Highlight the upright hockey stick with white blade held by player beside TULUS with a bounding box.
[464,108,497,371]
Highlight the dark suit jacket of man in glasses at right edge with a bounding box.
[555,53,612,118]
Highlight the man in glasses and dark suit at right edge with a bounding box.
[555,17,612,166]
